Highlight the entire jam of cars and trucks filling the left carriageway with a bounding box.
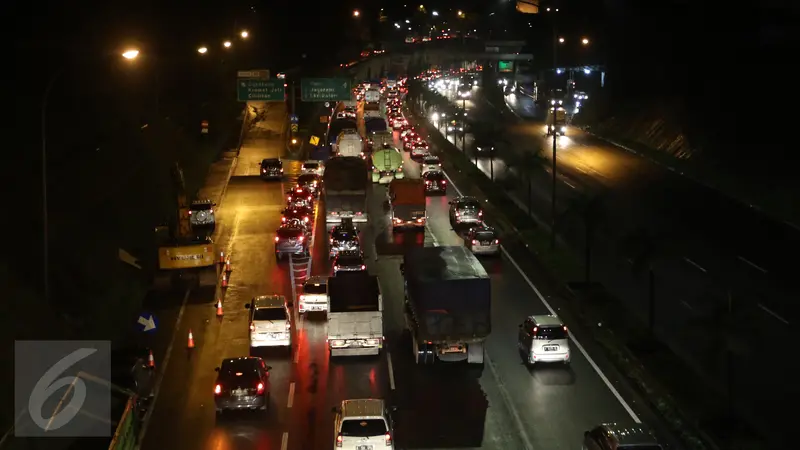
[214,74,664,450]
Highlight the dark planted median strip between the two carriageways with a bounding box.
[412,104,761,450]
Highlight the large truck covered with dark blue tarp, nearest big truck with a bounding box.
[400,246,492,364]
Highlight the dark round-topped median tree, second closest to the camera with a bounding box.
[621,227,675,336]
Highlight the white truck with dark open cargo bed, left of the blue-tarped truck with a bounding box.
[328,272,384,357]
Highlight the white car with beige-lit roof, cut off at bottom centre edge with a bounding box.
[331,398,394,450]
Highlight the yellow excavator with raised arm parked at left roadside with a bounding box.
[154,163,220,289]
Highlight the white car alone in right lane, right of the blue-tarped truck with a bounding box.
[517,314,571,366]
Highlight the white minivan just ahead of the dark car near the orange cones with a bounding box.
[244,294,292,348]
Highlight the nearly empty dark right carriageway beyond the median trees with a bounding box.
[416,75,798,438]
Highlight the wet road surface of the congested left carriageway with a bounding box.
[133,86,680,450]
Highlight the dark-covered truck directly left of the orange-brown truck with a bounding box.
[322,156,369,223]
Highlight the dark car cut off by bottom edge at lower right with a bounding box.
[582,423,664,450]
